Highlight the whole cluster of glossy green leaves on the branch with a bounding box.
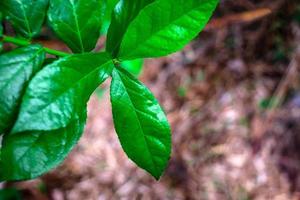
[0,0,218,180]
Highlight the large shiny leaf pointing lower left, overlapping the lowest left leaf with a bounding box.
[12,53,112,133]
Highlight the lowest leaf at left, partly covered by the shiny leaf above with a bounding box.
[0,113,86,181]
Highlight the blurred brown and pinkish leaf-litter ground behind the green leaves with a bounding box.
[1,0,300,200]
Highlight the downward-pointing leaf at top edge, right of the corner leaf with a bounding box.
[48,0,105,53]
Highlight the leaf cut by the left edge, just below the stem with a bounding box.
[0,45,45,134]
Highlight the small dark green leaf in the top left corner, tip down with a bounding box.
[0,0,48,39]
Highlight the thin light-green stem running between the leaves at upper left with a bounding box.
[2,35,70,57]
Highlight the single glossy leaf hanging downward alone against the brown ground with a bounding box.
[110,68,171,179]
